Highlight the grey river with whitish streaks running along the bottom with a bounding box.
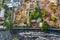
[0,29,60,40]
